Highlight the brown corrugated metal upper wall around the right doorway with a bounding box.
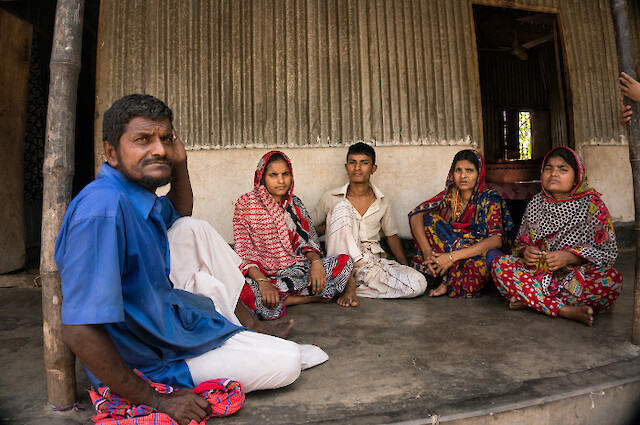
[97,0,622,149]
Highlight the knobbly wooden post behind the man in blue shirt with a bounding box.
[40,0,84,407]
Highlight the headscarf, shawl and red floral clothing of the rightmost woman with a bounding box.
[492,147,622,317]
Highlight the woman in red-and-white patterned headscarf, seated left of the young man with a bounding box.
[233,151,355,319]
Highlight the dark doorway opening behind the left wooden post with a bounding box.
[0,0,100,270]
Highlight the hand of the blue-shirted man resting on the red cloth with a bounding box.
[154,389,211,425]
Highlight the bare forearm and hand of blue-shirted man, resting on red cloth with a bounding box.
[62,325,211,425]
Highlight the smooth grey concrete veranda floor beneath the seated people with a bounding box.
[0,251,640,425]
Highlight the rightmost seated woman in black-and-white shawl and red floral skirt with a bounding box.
[492,147,622,326]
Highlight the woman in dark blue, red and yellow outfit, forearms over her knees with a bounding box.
[409,149,514,298]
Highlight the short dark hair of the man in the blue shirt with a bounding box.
[102,94,173,149]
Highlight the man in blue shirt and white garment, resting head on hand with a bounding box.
[56,95,308,424]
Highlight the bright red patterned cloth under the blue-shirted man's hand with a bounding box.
[89,369,244,425]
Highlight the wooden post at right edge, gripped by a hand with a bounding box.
[611,0,640,345]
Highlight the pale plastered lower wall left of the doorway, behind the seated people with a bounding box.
[168,146,463,243]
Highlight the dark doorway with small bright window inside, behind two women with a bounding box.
[473,4,573,223]
